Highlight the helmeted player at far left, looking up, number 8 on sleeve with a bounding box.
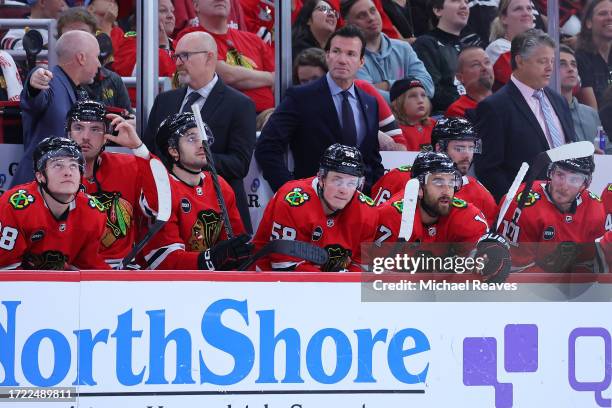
[0,138,109,270]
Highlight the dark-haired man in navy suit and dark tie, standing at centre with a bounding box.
[255,26,383,192]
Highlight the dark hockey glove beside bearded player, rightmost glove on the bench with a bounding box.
[476,232,512,283]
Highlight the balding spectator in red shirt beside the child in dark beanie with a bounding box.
[445,47,493,118]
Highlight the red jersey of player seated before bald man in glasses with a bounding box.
[140,172,245,270]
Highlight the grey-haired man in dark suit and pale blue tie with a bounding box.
[475,29,576,201]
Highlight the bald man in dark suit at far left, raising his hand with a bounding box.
[12,31,100,186]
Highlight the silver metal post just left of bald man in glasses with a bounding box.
[136,0,159,135]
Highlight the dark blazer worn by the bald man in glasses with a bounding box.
[143,78,255,232]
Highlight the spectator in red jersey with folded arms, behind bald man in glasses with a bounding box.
[177,0,274,112]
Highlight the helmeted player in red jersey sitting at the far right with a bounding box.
[499,156,605,272]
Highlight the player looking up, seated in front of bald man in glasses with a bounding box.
[141,112,251,270]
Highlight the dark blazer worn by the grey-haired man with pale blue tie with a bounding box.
[474,81,576,201]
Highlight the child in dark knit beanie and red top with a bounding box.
[389,77,436,151]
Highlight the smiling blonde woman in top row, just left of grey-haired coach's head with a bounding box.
[486,0,535,90]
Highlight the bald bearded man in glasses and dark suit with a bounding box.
[144,32,255,231]
